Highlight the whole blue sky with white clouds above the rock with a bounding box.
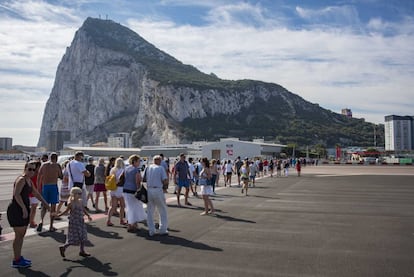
[0,0,414,145]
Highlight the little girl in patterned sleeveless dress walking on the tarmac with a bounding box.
[56,187,92,257]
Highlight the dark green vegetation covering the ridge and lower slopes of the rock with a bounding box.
[81,18,384,147]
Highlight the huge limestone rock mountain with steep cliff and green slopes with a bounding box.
[38,18,383,147]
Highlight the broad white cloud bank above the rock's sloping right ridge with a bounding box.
[129,4,414,123]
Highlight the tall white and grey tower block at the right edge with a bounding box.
[385,115,414,151]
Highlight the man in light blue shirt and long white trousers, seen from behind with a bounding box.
[146,155,168,237]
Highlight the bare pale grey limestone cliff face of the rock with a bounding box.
[38,17,298,146]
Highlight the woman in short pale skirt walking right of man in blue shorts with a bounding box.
[199,158,215,215]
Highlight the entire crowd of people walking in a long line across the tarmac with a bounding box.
[7,152,302,267]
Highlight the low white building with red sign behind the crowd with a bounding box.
[202,138,286,160]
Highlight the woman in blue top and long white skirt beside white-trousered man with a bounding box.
[123,155,146,233]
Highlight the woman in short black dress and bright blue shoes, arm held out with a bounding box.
[7,162,49,267]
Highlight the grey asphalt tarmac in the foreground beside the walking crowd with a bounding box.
[0,166,414,277]
